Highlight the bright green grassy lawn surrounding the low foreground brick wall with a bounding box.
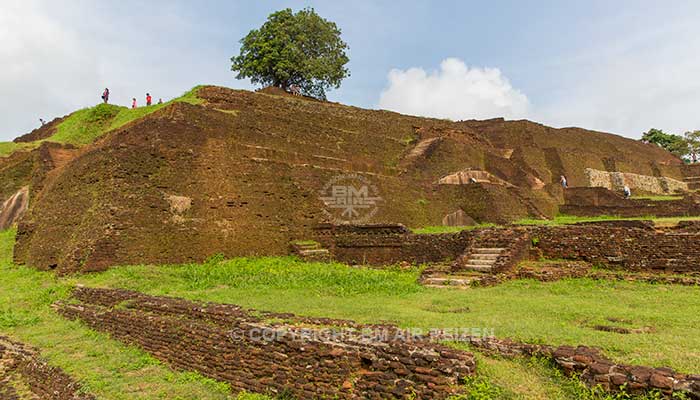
[0,227,700,399]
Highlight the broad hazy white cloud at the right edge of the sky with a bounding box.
[533,21,700,138]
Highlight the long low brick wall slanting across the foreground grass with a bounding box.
[55,287,475,399]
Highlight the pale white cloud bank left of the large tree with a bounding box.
[0,0,249,141]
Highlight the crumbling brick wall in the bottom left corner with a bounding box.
[0,336,95,400]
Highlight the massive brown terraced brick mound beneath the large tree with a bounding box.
[0,86,681,272]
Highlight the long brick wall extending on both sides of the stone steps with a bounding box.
[317,221,700,273]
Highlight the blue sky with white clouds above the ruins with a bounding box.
[0,0,700,141]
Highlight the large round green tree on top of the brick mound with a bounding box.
[231,8,350,99]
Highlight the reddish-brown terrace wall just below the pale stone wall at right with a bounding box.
[559,187,700,217]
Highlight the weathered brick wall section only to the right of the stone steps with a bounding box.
[530,221,700,273]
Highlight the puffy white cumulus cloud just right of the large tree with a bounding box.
[379,58,529,120]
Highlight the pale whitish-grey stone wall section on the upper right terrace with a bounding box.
[585,168,688,194]
